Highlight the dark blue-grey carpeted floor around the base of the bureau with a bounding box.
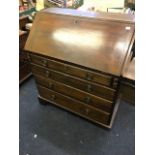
[19,77,135,155]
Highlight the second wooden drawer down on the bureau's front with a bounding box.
[31,65,116,101]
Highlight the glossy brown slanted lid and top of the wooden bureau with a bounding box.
[25,8,135,76]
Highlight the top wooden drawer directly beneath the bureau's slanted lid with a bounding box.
[30,54,118,88]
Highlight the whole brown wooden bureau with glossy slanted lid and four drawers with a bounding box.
[25,8,134,128]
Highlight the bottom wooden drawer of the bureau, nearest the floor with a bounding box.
[38,85,110,125]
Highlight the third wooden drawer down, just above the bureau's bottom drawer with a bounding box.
[36,76,113,112]
